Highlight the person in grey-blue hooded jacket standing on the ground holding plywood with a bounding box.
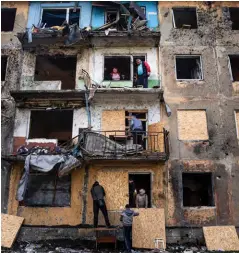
[120,204,139,252]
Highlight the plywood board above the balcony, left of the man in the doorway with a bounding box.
[101,110,125,136]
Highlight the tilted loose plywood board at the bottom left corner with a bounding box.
[1,213,24,248]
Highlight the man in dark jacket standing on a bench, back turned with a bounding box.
[91,181,110,228]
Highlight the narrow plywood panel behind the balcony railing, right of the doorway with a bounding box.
[148,122,164,152]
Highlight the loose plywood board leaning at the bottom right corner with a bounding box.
[203,226,239,251]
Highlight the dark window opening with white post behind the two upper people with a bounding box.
[104,55,145,81]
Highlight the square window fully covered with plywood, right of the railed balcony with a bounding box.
[177,110,208,141]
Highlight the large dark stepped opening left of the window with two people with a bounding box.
[35,56,77,90]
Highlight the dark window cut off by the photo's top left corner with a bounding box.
[1,8,17,32]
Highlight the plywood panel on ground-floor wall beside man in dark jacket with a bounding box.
[97,169,129,210]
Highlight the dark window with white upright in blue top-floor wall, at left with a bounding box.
[42,8,80,27]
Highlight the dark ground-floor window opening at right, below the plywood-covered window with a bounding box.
[182,173,214,207]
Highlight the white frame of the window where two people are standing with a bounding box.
[102,53,147,82]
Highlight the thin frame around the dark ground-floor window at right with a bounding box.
[181,171,216,209]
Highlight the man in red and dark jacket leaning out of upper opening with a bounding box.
[136,59,151,88]
